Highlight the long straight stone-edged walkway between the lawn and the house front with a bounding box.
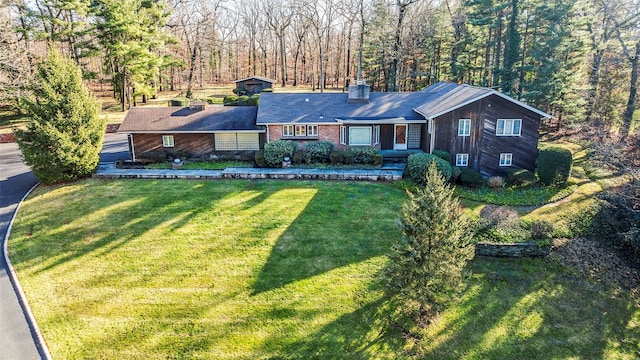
[93,163,405,181]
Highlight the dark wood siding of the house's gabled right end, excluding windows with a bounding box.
[434,95,540,176]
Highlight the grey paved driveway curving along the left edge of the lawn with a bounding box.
[0,144,44,360]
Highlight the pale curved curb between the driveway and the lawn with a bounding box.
[2,183,52,360]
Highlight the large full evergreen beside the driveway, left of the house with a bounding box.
[16,47,106,184]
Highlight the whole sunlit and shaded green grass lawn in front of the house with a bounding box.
[10,180,640,359]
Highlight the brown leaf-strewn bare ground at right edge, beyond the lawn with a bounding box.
[549,238,640,303]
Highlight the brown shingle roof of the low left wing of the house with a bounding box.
[118,106,264,133]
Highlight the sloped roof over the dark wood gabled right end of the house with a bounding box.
[416,82,551,119]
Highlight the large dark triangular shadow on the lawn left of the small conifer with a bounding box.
[253,183,404,295]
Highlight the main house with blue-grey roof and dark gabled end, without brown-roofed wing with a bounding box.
[256,82,551,175]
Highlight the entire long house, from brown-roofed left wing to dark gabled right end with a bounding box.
[119,82,550,175]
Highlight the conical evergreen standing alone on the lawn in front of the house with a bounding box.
[384,164,474,318]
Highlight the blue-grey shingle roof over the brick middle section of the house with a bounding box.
[257,92,424,125]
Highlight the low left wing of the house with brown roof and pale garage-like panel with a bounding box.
[118,104,265,161]
